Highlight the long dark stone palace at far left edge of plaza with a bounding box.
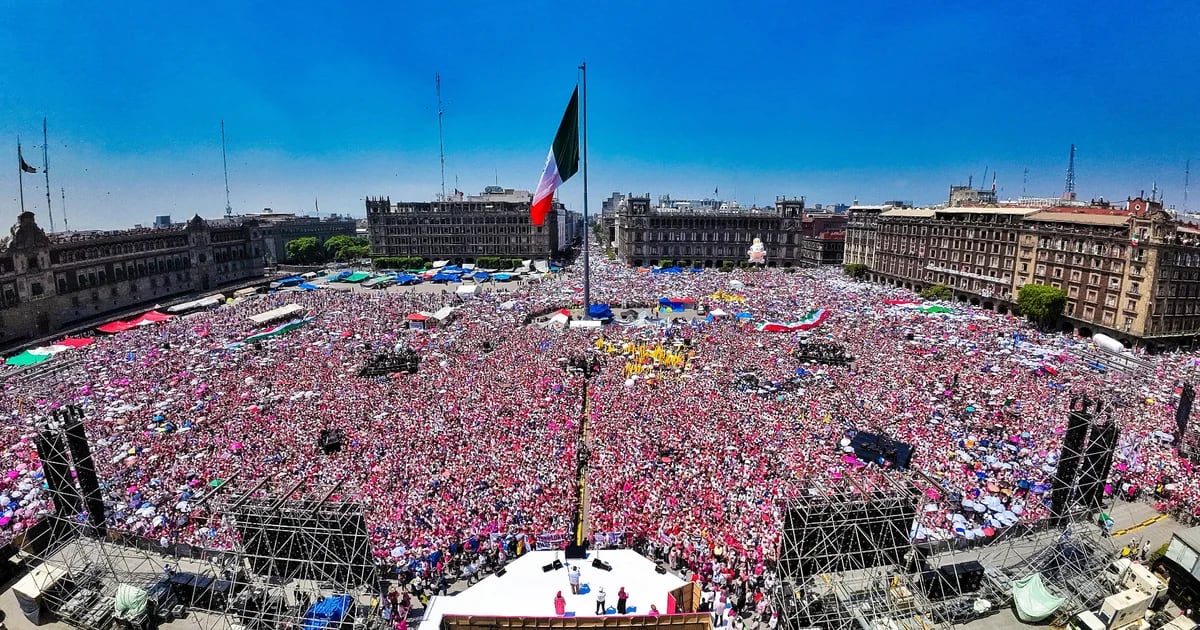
[0,212,264,346]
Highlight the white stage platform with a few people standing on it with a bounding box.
[421,550,686,630]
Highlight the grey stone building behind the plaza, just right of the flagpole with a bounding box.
[600,193,846,268]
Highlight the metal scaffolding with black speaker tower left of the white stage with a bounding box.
[18,409,383,630]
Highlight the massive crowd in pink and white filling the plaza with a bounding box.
[0,250,1200,612]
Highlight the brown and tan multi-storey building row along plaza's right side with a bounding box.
[846,197,1200,344]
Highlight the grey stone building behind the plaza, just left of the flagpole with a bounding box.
[366,186,569,263]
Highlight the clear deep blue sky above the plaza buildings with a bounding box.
[0,0,1200,229]
